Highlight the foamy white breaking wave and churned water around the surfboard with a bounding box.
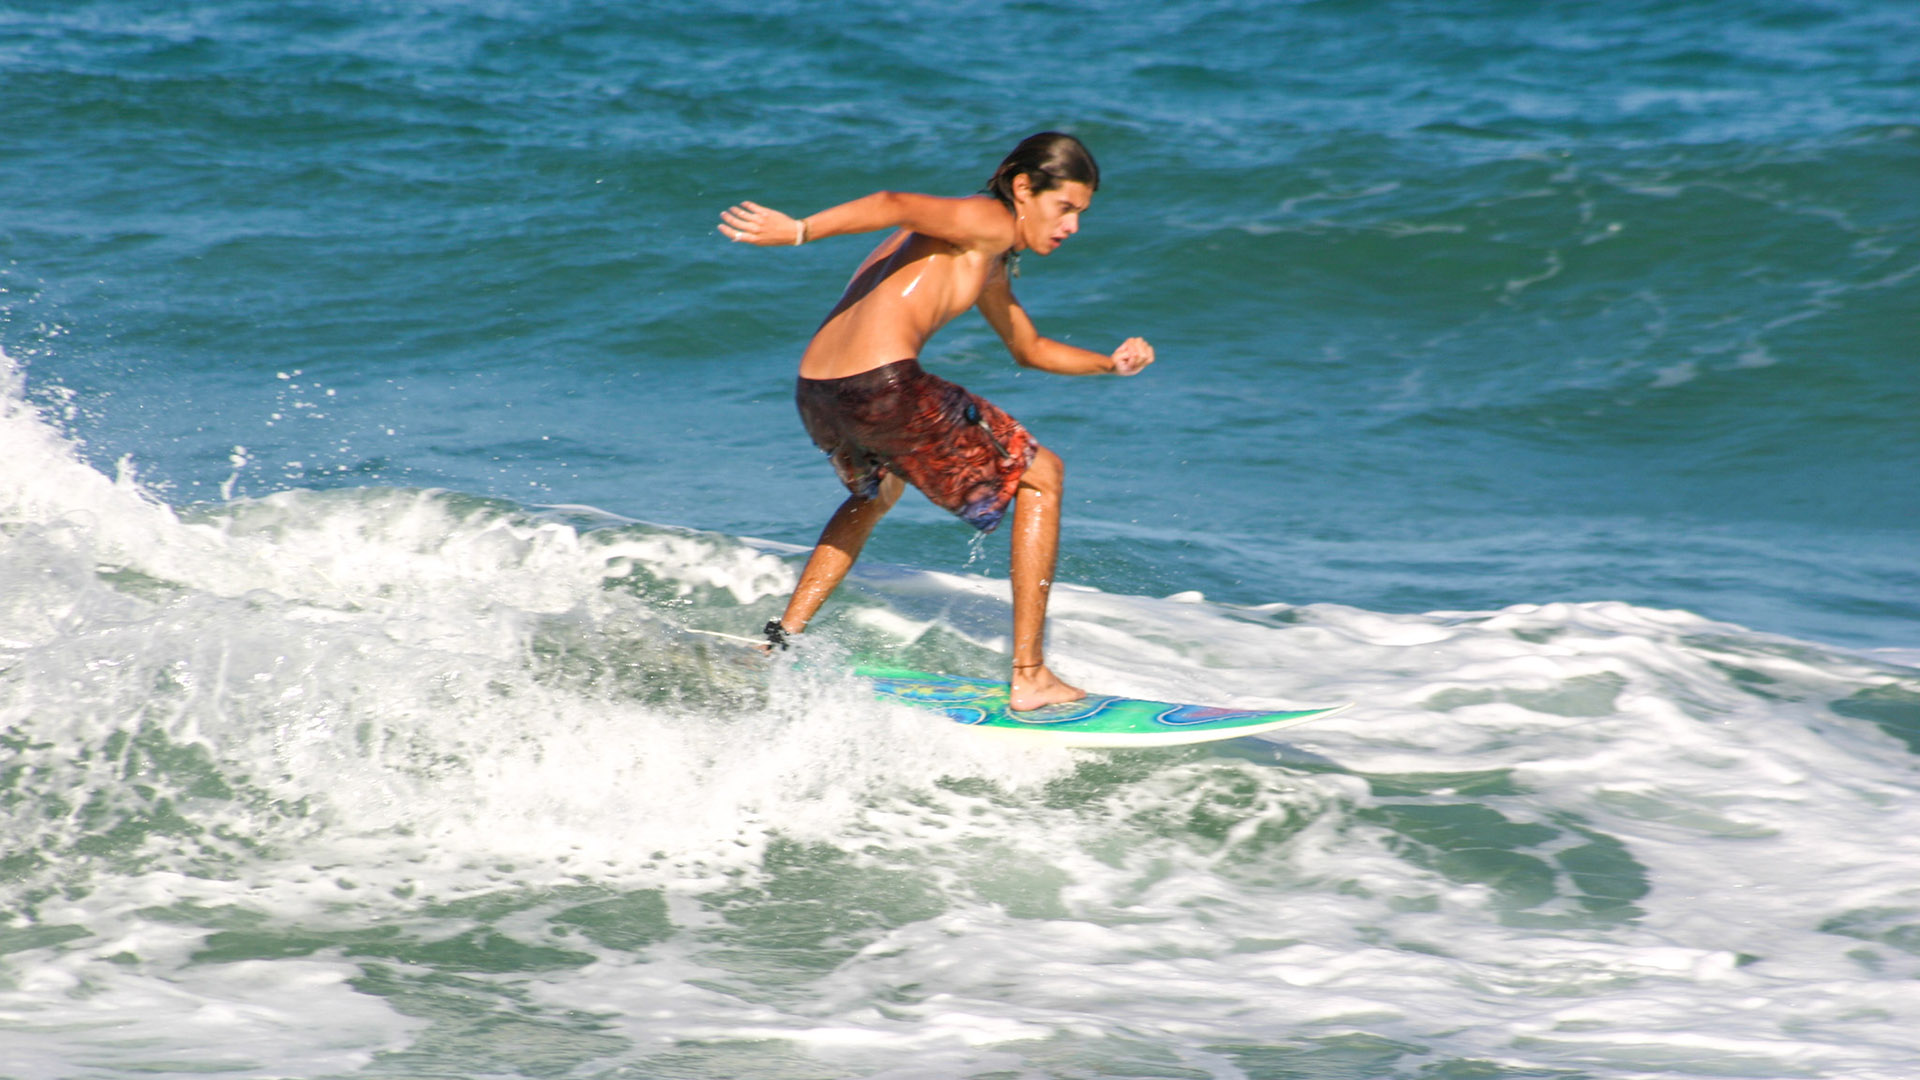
[0,336,1920,1080]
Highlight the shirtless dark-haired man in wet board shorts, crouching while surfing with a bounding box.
[720,131,1154,709]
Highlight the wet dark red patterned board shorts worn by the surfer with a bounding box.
[793,359,1039,532]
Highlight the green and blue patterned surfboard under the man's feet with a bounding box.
[854,667,1350,748]
